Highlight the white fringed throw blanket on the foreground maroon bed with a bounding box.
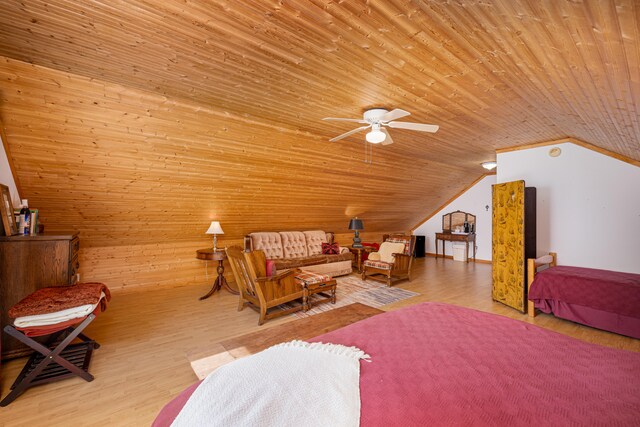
[172,341,369,427]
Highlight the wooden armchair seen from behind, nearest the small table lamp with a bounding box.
[225,246,303,325]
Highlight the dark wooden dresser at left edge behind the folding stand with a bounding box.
[0,232,80,360]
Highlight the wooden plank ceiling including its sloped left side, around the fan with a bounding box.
[0,0,640,288]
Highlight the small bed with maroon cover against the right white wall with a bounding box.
[529,266,640,338]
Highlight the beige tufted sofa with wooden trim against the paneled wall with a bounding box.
[244,230,353,277]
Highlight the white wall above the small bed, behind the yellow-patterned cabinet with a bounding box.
[497,142,640,273]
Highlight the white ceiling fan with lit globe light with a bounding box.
[322,108,439,145]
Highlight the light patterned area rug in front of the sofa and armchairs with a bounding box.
[280,275,420,318]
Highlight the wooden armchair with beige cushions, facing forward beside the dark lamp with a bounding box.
[362,235,416,286]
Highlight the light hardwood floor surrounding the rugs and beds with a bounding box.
[0,257,640,426]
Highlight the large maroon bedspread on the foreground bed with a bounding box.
[154,303,640,426]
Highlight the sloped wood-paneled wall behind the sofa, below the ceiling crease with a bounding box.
[0,58,416,287]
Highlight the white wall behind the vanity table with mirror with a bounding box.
[413,175,496,261]
